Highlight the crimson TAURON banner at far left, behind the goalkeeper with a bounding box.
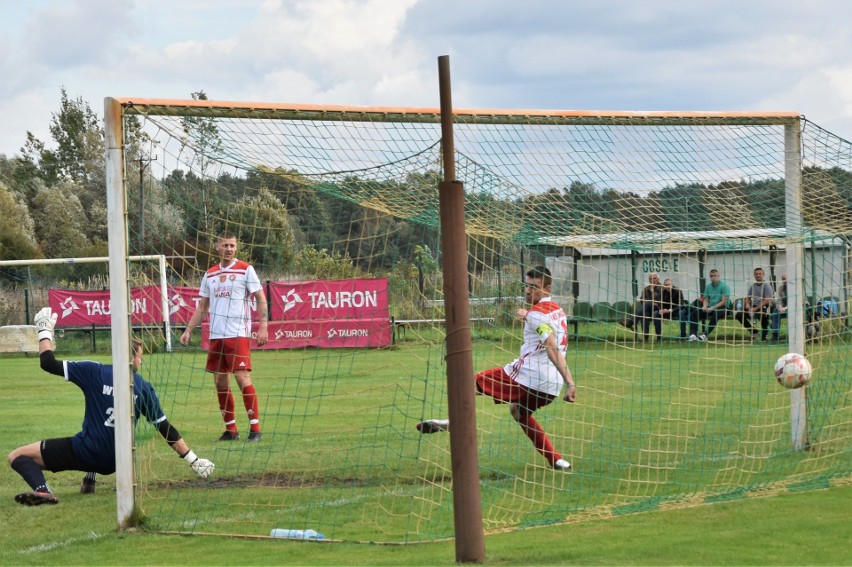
[48,285,163,327]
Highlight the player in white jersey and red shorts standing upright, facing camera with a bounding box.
[180,231,268,441]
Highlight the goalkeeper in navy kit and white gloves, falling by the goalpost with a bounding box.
[9,307,215,506]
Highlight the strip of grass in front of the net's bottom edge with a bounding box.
[0,486,852,565]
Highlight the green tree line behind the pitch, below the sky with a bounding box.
[0,88,852,284]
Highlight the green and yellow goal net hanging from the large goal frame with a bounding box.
[106,99,852,542]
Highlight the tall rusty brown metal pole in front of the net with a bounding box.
[438,55,485,563]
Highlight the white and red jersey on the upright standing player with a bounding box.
[199,260,262,339]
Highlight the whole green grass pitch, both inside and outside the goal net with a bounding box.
[0,336,852,564]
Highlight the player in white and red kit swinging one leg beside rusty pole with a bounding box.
[417,266,577,470]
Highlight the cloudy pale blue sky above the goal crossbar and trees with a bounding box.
[0,0,852,157]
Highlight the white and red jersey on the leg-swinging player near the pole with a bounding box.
[503,297,568,396]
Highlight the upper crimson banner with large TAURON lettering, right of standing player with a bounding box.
[268,278,389,321]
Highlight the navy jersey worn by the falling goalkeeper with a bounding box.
[64,360,166,474]
